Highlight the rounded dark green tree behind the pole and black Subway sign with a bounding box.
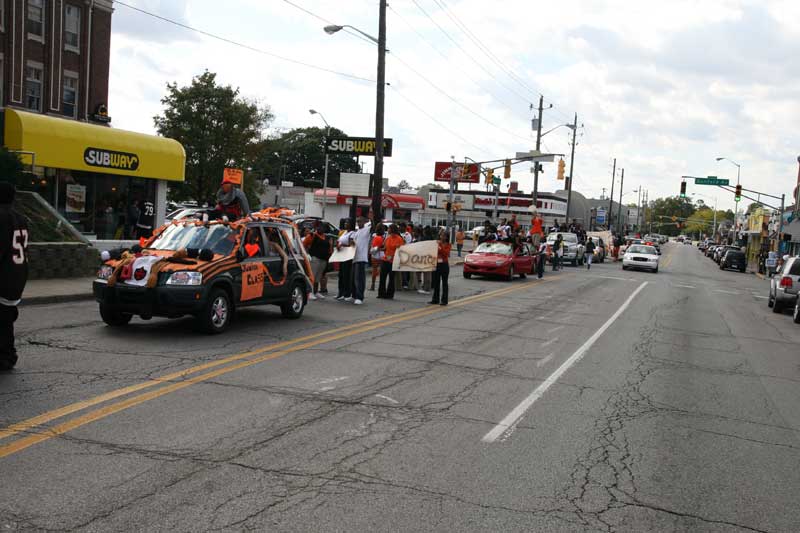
[252,127,360,188]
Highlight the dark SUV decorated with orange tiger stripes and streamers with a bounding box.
[93,210,311,333]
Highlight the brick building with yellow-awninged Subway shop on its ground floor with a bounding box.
[0,0,185,240]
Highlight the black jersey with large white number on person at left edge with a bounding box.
[0,205,28,305]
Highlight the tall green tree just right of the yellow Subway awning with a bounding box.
[153,70,273,206]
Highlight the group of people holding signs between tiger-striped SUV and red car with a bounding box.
[303,217,454,305]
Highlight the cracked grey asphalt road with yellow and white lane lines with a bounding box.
[0,244,800,531]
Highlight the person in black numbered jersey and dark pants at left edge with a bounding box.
[0,182,28,371]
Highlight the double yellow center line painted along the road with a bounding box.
[0,276,558,458]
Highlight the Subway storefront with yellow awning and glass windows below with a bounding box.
[3,109,186,240]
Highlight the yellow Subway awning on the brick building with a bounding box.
[4,109,186,181]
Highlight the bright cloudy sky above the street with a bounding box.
[109,0,800,209]
